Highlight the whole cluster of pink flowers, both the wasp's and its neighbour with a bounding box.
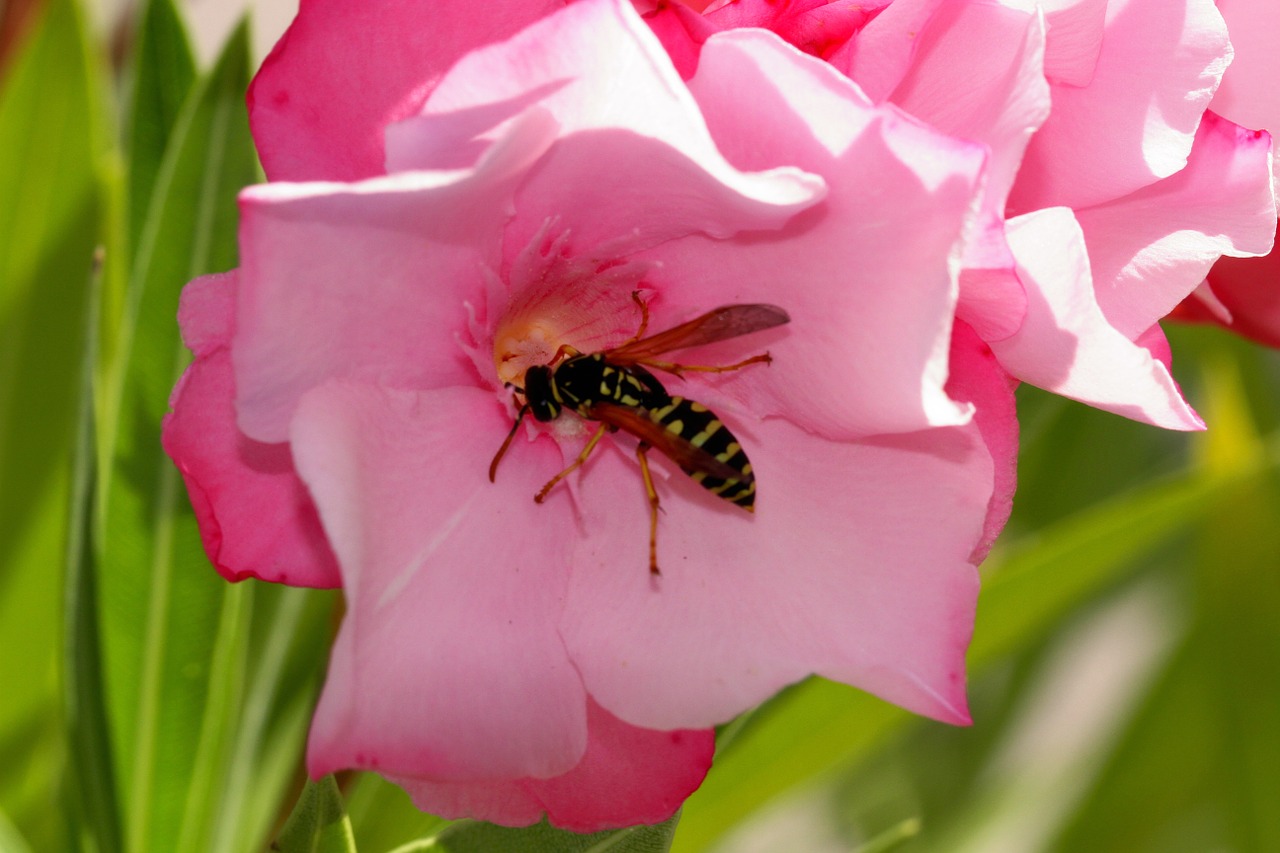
[165,0,1276,830]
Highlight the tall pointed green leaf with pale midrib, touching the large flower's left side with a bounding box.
[96,21,256,850]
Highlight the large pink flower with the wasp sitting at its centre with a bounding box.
[165,0,1016,830]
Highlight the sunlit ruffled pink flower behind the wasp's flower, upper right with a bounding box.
[649,0,1275,429]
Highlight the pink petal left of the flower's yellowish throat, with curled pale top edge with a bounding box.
[233,125,549,441]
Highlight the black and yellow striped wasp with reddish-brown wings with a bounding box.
[489,293,791,575]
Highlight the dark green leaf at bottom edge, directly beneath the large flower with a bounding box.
[417,813,680,853]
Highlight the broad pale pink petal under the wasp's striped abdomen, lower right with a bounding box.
[560,412,992,729]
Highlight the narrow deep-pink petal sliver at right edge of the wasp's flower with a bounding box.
[947,323,1019,565]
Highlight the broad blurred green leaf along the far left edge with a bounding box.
[0,0,106,849]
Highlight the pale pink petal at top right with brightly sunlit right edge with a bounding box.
[1010,0,1231,211]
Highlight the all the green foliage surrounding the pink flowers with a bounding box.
[0,0,1280,853]
